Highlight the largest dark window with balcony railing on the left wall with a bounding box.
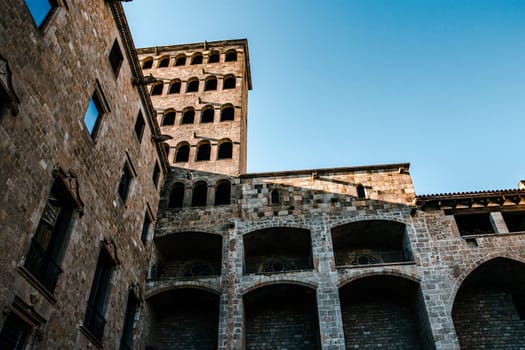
[24,180,75,293]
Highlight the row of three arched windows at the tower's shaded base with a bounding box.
[168,180,231,208]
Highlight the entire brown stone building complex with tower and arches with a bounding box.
[0,0,525,350]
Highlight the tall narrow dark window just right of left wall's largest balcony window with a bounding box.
[84,249,114,340]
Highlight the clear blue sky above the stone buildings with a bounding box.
[124,0,525,194]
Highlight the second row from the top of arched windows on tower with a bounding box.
[150,74,236,96]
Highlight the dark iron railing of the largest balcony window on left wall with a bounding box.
[24,239,62,293]
